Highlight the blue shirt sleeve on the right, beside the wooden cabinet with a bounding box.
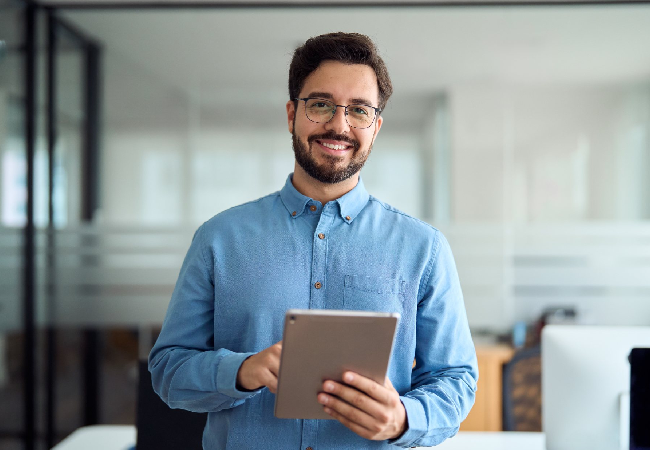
[390,232,478,447]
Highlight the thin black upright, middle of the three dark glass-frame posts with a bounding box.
[45,10,57,448]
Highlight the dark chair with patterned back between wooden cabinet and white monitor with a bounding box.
[503,346,542,431]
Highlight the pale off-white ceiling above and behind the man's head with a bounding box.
[61,2,650,130]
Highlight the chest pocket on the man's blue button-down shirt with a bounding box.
[343,275,406,313]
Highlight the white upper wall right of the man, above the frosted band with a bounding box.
[449,84,650,223]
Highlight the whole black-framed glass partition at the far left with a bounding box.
[0,2,104,450]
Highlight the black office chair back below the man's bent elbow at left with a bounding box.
[135,361,208,450]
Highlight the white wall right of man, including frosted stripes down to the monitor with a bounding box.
[446,83,650,330]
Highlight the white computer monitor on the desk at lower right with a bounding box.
[542,325,650,450]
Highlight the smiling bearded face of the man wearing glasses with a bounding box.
[287,61,383,183]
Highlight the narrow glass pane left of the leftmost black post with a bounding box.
[0,2,28,449]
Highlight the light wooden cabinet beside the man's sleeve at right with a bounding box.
[460,345,514,431]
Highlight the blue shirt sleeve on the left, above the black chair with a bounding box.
[149,226,261,412]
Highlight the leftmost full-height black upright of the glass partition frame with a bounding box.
[23,3,37,450]
